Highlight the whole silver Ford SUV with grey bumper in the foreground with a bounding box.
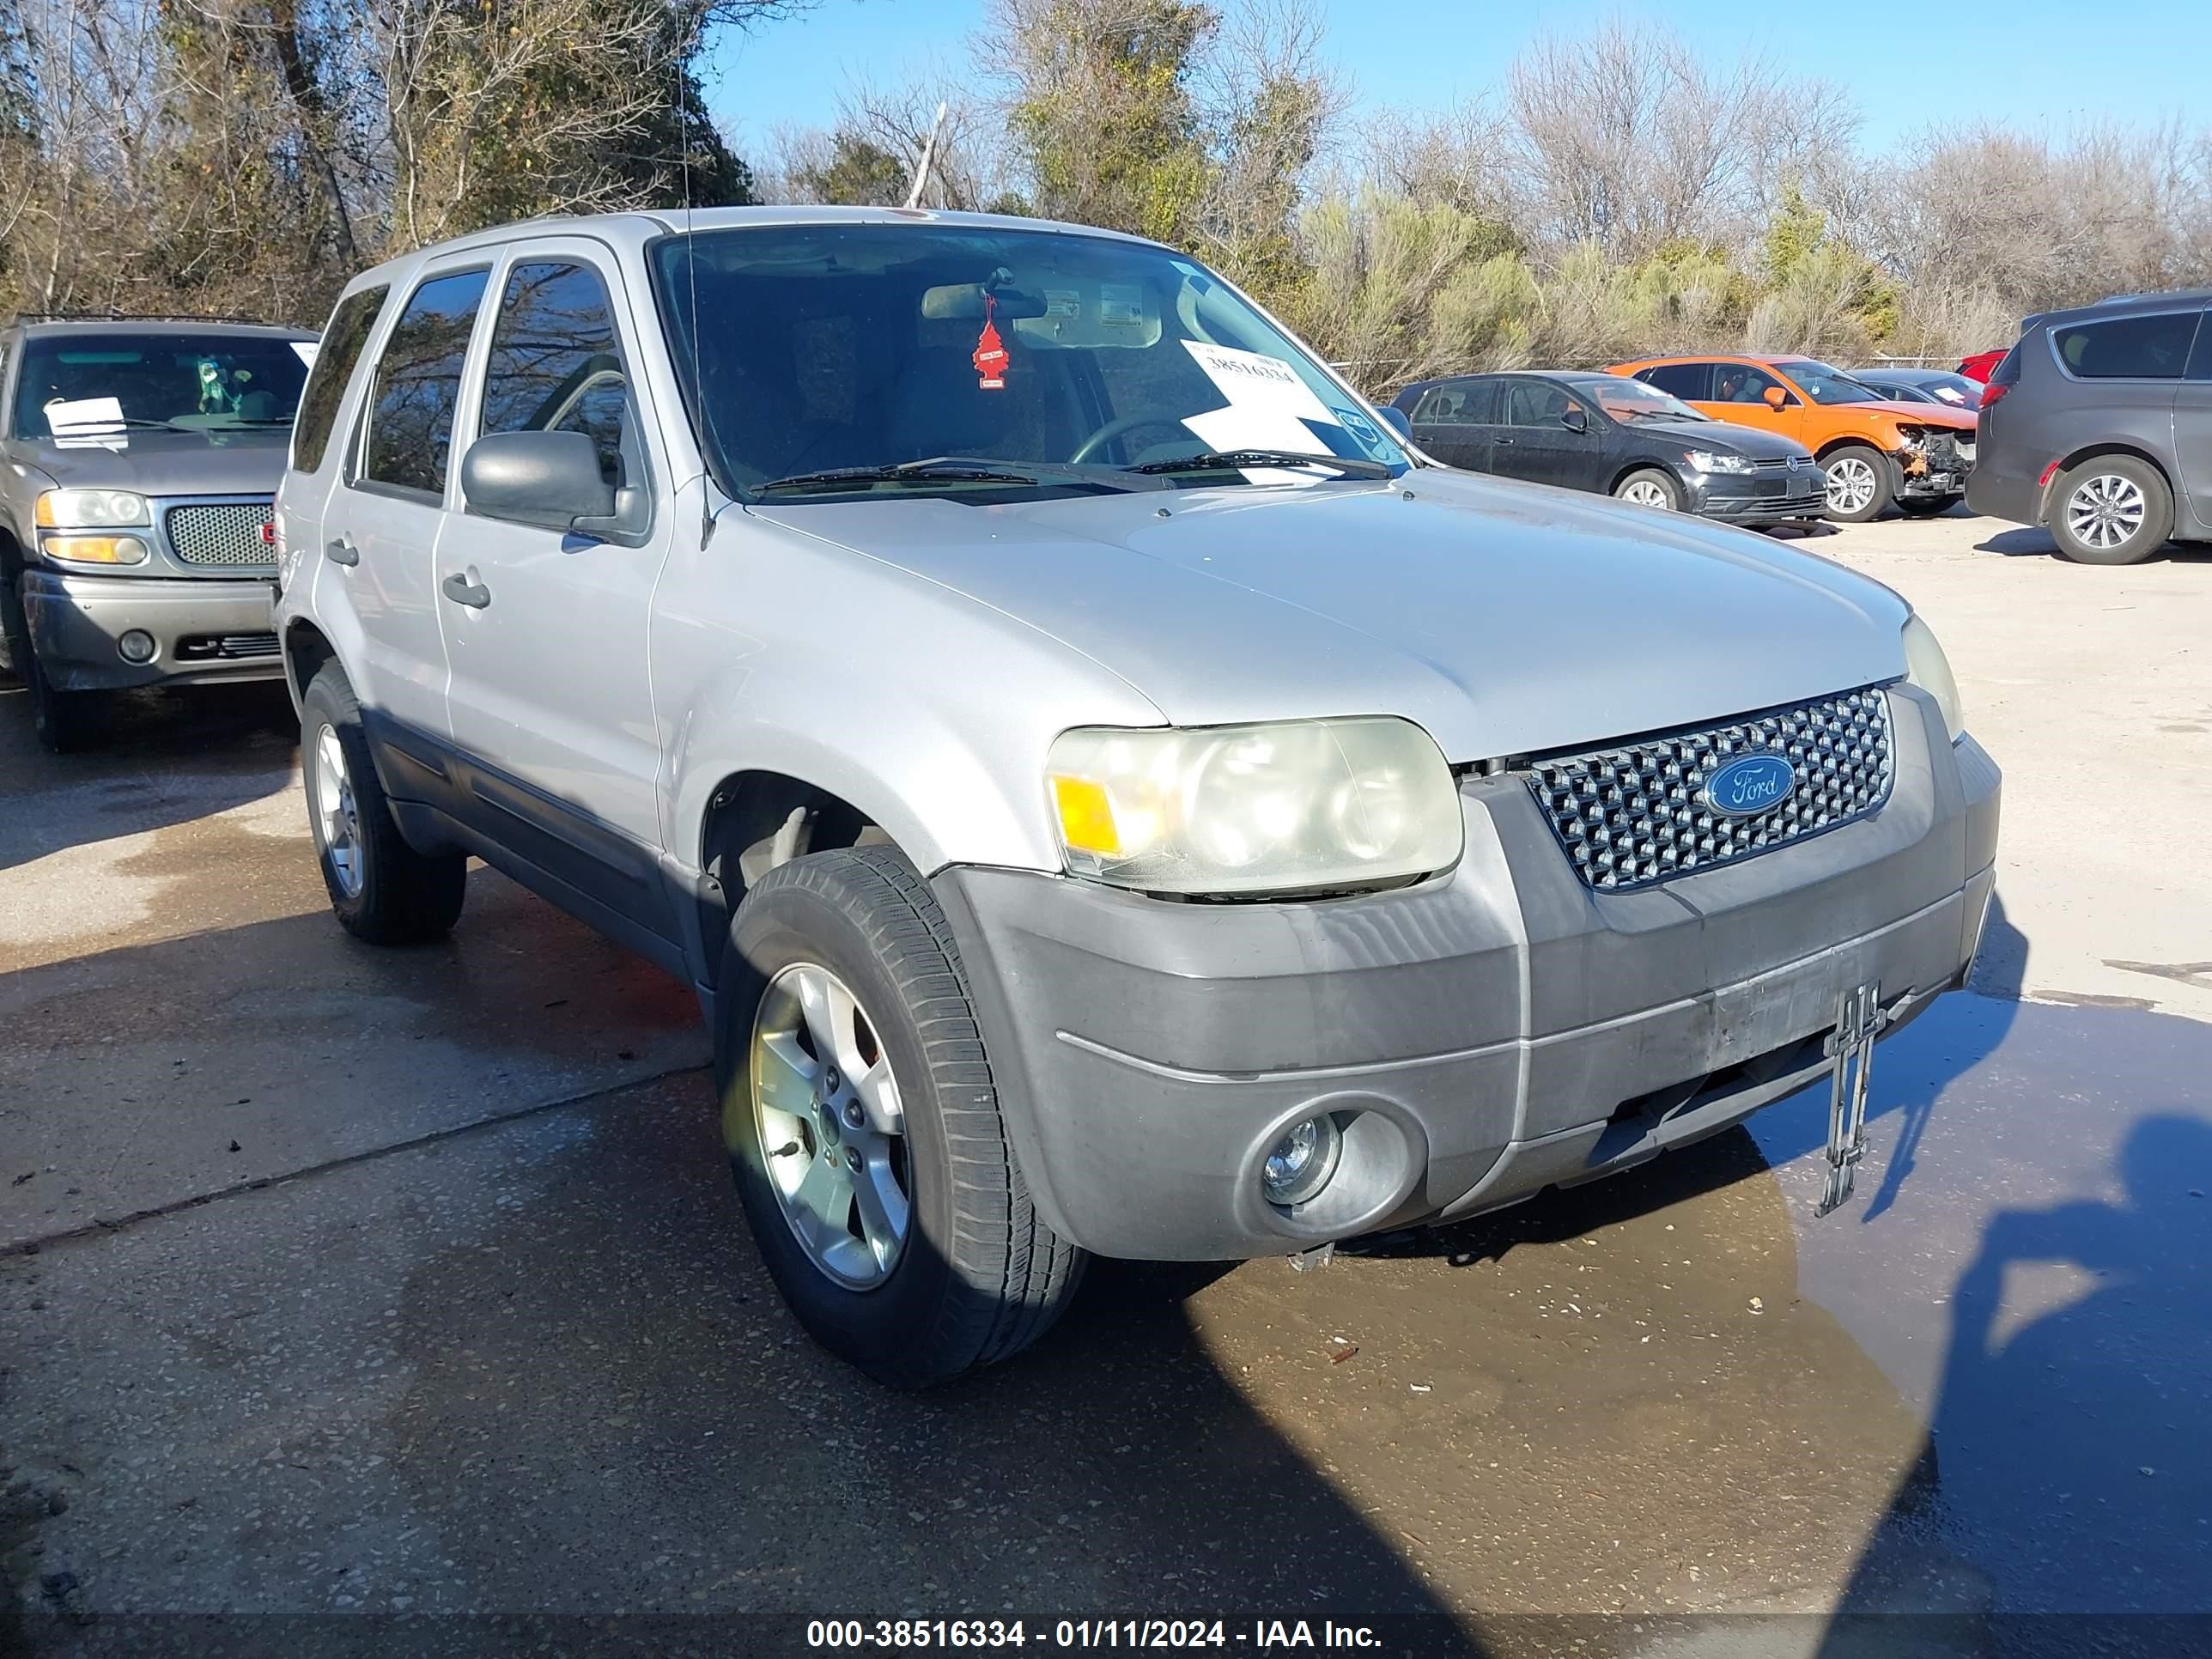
[276,208,1997,1385]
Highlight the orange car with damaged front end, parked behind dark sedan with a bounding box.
[1610,356,1978,525]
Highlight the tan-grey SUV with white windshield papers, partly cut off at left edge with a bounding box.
[0,319,314,750]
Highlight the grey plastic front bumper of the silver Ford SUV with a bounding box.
[933,686,2000,1261]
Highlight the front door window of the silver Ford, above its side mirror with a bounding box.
[483,261,644,489]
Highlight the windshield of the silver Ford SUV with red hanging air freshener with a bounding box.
[653,223,1407,495]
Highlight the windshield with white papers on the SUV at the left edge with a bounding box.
[15,331,314,438]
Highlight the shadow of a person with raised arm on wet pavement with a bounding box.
[1823,1113,2212,1655]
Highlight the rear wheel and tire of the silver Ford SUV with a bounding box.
[299,661,469,945]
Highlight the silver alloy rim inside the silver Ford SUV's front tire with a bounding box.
[752,963,914,1290]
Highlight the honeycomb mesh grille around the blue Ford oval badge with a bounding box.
[1528,686,1893,891]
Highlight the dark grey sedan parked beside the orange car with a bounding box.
[1394,372,1825,525]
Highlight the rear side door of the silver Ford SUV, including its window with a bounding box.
[316,254,491,748]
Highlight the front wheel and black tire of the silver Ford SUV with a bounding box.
[714,845,1084,1389]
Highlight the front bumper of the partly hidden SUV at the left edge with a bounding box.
[22,568,283,690]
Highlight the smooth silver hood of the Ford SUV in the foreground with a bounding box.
[745,469,1907,763]
